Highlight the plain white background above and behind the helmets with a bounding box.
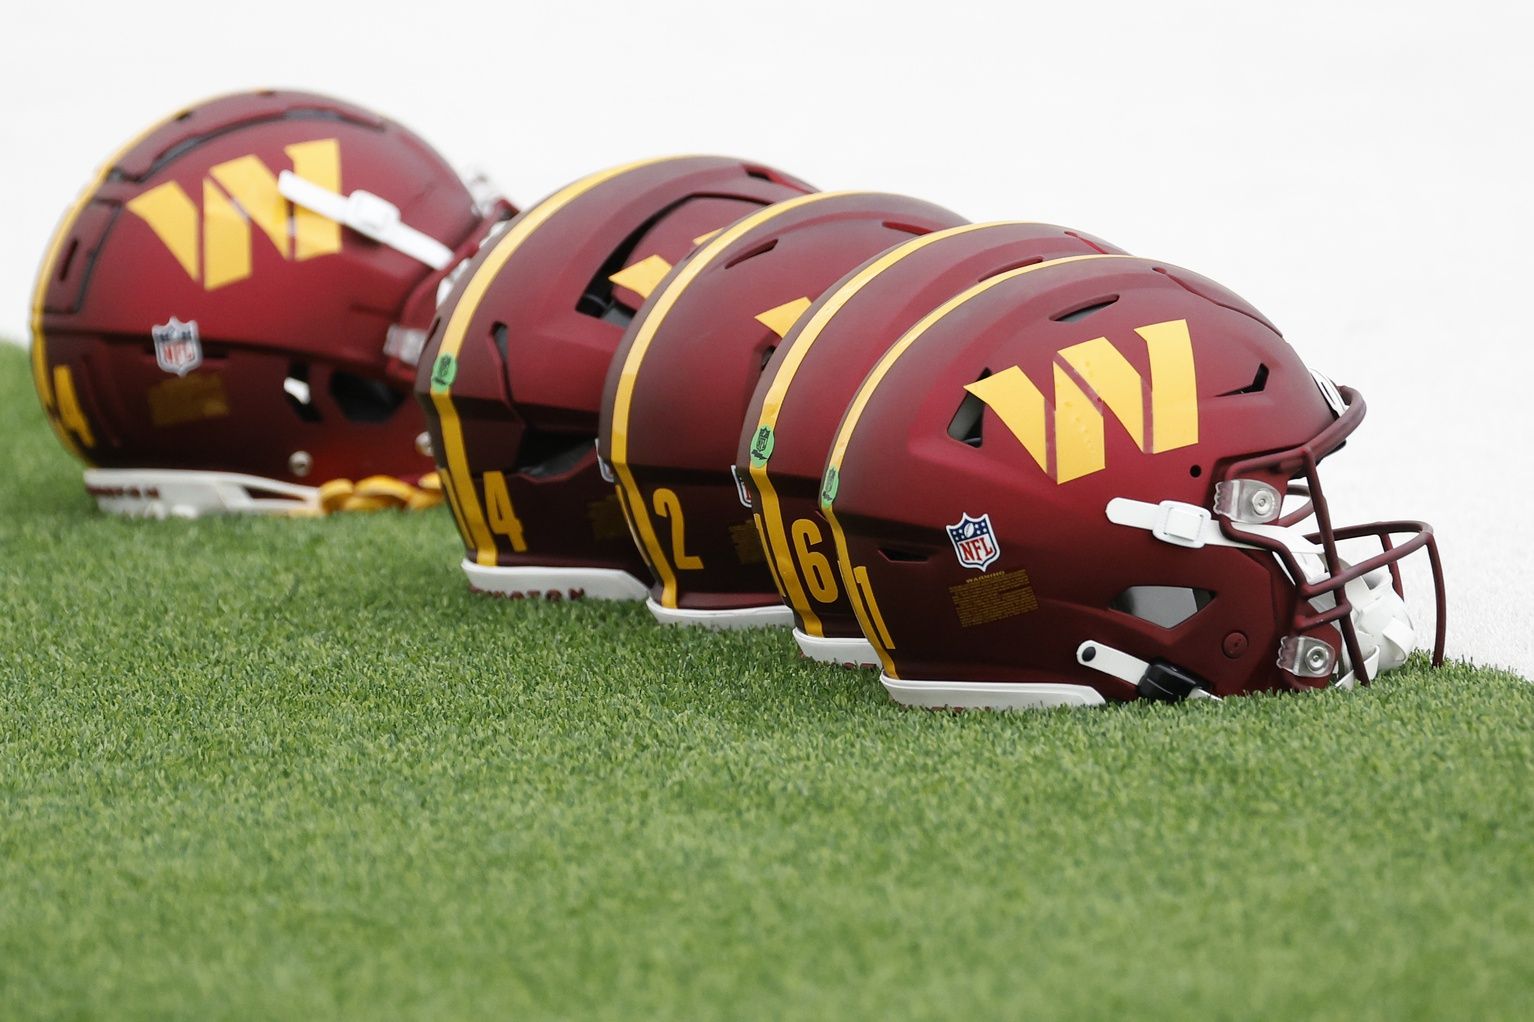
[0,0,1534,675]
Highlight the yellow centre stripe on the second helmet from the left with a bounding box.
[431,157,673,566]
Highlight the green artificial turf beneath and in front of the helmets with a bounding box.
[0,348,1534,1019]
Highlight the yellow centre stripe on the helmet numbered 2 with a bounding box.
[609,192,851,608]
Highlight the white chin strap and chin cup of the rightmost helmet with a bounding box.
[1077,497,1416,687]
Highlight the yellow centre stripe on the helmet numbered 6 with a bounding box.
[750,224,1012,637]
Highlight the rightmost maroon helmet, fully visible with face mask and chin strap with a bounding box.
[821,255,1443,707]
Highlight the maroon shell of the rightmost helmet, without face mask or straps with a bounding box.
[822,255,1335,700]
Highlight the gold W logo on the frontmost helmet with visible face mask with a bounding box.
[965,319,1198,483]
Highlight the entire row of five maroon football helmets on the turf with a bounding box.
[32,92,1445,707]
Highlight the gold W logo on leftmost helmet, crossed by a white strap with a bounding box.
[127,138,341,292]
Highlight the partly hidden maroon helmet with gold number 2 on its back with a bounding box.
[598,192,963,628]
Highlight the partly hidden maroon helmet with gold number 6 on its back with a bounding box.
[735,223,1118,666]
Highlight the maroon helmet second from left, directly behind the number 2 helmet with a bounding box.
[416,157,810,598]
